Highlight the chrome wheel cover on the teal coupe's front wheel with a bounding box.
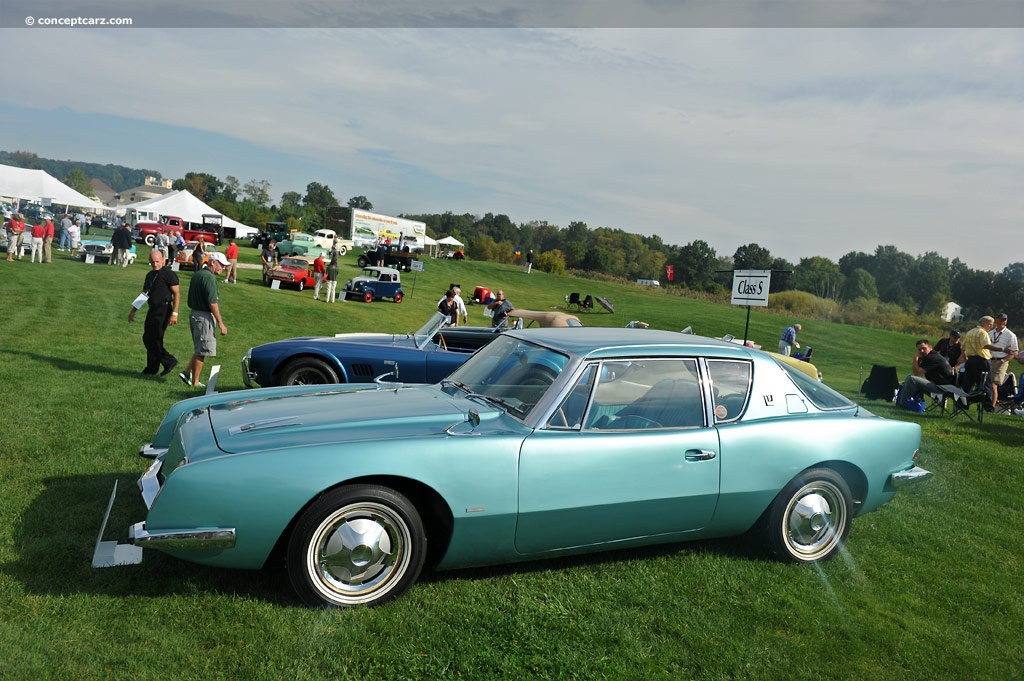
[305,502,413,605]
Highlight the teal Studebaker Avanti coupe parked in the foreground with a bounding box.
[99,328,931,606]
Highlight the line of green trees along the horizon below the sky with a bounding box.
[6,152,1024,327]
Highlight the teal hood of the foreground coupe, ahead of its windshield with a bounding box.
[208,385,479,461]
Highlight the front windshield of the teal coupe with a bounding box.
[443,336,569,419]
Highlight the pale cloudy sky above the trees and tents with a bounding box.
[0,0,1024,270]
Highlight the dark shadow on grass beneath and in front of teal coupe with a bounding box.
[0,473,765,606]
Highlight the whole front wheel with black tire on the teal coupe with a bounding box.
[287,484,427,607]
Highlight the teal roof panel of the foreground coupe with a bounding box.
[507,327,754,358]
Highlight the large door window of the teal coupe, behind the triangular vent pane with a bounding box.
[585,358,706,430]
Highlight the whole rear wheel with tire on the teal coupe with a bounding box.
[765,468,853,563]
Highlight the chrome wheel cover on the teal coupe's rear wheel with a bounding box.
[782,480,849,560]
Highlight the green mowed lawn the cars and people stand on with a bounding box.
[0,241,1024,681]
